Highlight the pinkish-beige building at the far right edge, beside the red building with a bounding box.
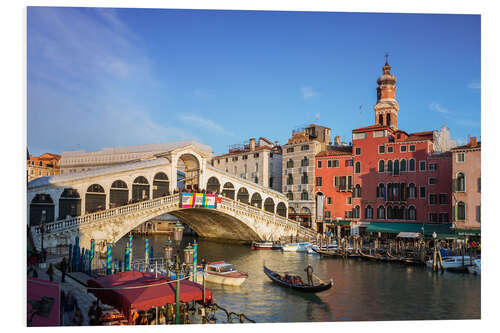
[451,137,481,236]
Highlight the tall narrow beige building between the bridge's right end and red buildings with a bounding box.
[282,124,330,230]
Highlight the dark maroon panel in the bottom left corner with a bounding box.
[27,277,60,326]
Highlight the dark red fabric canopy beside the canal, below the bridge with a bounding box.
[87,271,212,319]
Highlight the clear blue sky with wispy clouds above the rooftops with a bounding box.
[27,7,481,155]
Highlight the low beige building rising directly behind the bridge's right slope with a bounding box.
[212,137,282,192]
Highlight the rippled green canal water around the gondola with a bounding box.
[112,235,481,323]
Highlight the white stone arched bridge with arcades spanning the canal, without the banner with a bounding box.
[27,145,316,250]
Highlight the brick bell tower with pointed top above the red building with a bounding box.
[373,54,399,130]
